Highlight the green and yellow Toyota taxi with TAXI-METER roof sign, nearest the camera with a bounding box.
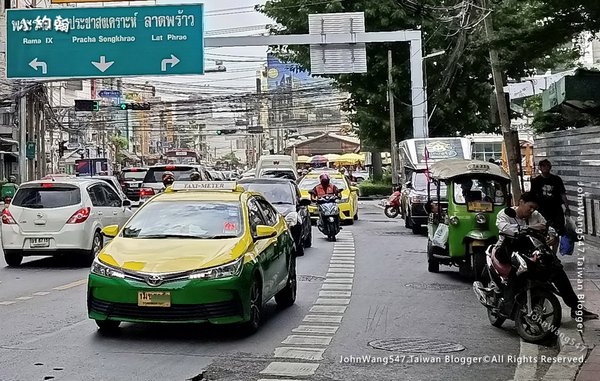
[87,181,296,333]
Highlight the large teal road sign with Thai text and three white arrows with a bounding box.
[6,4,204,78]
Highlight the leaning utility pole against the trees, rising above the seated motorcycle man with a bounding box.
[481,0,521,205]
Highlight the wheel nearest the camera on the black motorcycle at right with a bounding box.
[515,289,562,344]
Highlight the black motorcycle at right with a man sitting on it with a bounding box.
[473,209,562,343]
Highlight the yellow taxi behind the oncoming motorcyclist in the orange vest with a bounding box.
[298,172,358,224]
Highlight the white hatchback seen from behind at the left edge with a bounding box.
[2,178,132,266]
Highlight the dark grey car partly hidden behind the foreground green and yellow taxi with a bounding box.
[238,178,312,256]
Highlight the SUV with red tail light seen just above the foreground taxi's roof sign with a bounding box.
[140,164,212,204]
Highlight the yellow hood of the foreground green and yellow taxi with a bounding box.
[98,237,251,273]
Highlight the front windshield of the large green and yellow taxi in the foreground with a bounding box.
[123,201,243,239]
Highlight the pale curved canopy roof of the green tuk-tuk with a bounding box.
[429,159,510,181]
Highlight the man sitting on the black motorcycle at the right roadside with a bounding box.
[496,192,598,319]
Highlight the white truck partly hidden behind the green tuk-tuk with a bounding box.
[398,137,472,234]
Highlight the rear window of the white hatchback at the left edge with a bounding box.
[12,184,81,209]
